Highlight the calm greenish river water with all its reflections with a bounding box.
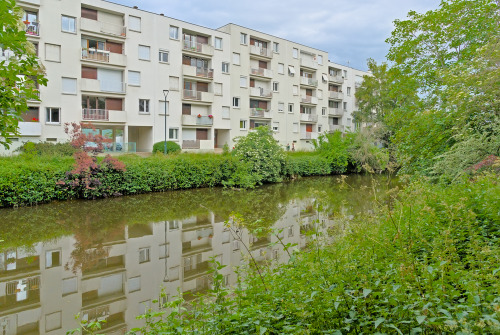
[0,175,394,335]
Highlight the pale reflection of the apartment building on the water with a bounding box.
[0,200,336,334]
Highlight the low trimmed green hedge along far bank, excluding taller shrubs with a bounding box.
[0,152,348,207]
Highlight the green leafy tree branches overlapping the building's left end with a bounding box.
[0,0,47,149]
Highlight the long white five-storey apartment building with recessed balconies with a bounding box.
[0,0,372,152]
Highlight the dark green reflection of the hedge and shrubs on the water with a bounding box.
[0,175,398,252]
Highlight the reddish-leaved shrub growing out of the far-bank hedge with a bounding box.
[57,122,125,199]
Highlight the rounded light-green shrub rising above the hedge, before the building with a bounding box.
[232,126,285,184]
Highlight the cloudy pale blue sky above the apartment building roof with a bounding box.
[112,0,440,70]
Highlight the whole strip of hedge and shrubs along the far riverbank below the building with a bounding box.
[0,127,388,207]
